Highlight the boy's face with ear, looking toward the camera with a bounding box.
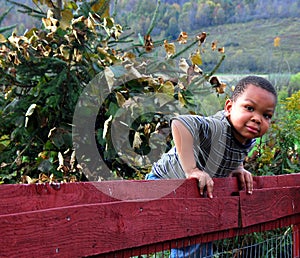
[225,84,276,144]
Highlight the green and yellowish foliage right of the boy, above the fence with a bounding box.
[247,91,300,175]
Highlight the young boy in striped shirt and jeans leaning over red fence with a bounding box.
[146,76,277,258]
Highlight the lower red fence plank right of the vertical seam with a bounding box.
[240,186,300,227]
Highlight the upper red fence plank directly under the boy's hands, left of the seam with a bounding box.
[0,178,238,215]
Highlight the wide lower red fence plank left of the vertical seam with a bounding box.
[0,197,239,257]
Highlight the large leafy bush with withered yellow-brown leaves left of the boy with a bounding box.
[0,0,225,183]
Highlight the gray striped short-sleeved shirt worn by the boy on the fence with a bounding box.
[152,111,255,179]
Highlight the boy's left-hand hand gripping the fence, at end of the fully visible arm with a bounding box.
[187,168,214,198]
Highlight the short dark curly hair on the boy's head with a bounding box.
[231,75,277,102]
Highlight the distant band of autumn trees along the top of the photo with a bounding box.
[111,0,300,37]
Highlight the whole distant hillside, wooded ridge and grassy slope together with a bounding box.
[0,0,300,74]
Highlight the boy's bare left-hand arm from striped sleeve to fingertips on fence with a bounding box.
[171,120,214,198]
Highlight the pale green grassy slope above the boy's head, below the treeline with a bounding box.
[199,18,300,73]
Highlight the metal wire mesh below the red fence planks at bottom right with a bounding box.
[132,227,293,258]
